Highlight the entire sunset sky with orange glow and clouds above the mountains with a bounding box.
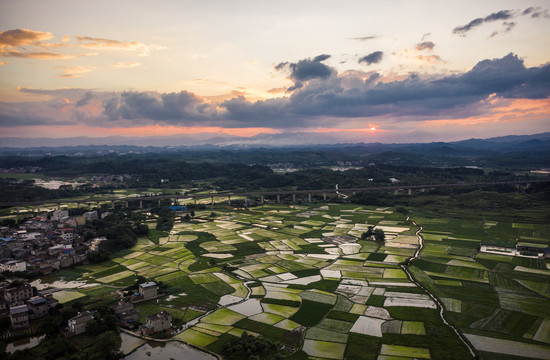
[0,0,550,142]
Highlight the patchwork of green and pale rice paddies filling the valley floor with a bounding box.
[41,203,550,359]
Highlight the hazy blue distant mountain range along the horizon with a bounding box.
[0,132,550,150]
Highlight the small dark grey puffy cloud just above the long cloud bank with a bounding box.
[275,54,335,91]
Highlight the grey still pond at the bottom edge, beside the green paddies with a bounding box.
[120,333,216,360]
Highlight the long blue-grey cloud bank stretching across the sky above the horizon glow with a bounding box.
[4,53,550,129]
